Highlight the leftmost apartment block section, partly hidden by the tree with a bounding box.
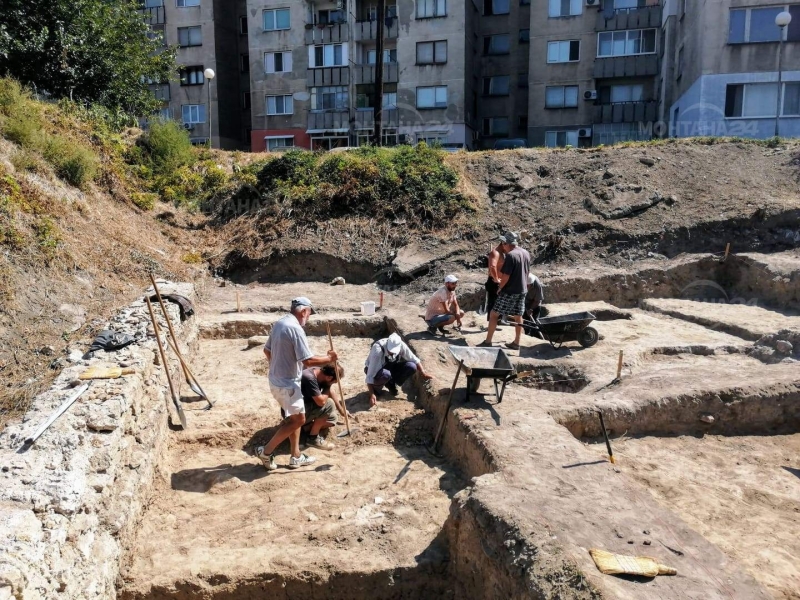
[140,0,250,149]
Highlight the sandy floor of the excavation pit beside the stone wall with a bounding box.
[120,330,466,598]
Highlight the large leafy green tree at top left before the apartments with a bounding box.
[0,0,175,116]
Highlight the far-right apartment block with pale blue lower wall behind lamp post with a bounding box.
[663,0,800,138]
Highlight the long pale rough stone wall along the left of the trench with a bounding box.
[0,282,198,600]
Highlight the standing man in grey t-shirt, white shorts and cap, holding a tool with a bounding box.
[256,296,338,471]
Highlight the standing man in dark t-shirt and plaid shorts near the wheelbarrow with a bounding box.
[478,231,531,350]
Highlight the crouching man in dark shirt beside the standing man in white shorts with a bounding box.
[300,365,344,450]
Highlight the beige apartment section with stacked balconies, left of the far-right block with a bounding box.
[528,0,663,146]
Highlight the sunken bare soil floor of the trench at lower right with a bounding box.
[614,434,800,599]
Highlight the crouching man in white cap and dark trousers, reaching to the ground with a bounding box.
[364,333,433,406]
